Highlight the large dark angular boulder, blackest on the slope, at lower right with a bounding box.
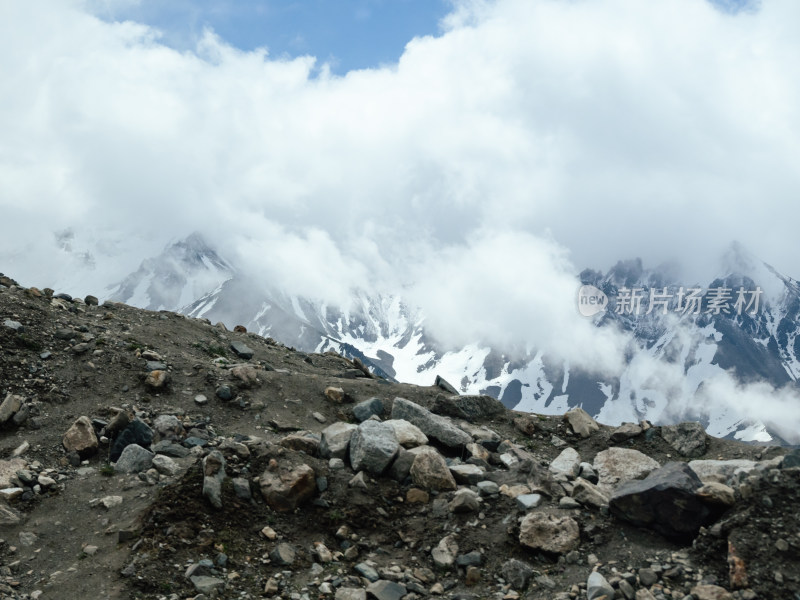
[609,462,715,542]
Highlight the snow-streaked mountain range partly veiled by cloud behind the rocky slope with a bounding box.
[112,235,800,443]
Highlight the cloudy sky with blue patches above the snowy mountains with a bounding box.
[0,0,800,361]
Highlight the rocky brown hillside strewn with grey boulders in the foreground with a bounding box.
[0,276,800,600]
